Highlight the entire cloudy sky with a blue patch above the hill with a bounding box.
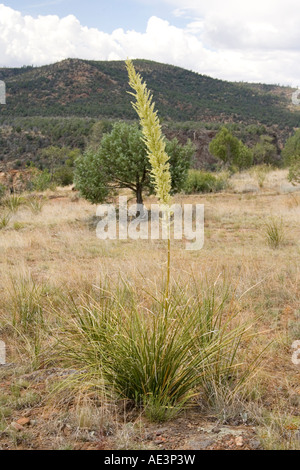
[0,0,300,87]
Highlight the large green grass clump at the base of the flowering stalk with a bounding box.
[54,280,258,421]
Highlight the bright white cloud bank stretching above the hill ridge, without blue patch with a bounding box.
[0,0,300,86]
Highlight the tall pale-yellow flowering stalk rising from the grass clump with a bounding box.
[126,60,171,310]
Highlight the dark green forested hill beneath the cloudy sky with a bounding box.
[0,59,300,129]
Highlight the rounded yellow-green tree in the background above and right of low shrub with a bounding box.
[209,127,253,170]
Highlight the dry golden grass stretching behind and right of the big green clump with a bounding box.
[0,170,300,445]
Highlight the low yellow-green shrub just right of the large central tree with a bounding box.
[184,170,227,194]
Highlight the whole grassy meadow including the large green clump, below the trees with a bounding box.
[0,170,300,449]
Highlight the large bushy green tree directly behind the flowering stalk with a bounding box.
[75,122,194,204]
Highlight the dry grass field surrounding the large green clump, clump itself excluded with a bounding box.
[0,170,300,449]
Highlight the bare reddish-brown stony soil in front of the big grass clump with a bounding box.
[0,365,261,450]
